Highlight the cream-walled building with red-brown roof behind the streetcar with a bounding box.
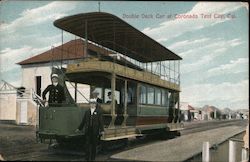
[0,39,112,125]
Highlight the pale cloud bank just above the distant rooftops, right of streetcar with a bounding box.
[181,80,249,108]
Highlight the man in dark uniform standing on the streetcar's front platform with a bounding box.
[42,74,65,106]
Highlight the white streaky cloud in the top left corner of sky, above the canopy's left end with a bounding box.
[0,1,76,32]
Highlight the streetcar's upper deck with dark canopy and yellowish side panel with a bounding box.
[54,12,182,88]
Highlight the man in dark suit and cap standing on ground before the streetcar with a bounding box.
[76,99,104,160]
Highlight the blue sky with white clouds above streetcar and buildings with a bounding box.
[0,1,249,109]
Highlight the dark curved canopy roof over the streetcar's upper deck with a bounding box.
[54,12,182,63]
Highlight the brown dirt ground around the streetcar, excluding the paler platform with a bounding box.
[0,120,248,161]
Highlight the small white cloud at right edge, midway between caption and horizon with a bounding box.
[208,58,249,77]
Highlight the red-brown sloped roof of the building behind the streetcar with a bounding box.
[17,39,113,65]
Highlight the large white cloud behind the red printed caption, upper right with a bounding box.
[142,2,243,41]
